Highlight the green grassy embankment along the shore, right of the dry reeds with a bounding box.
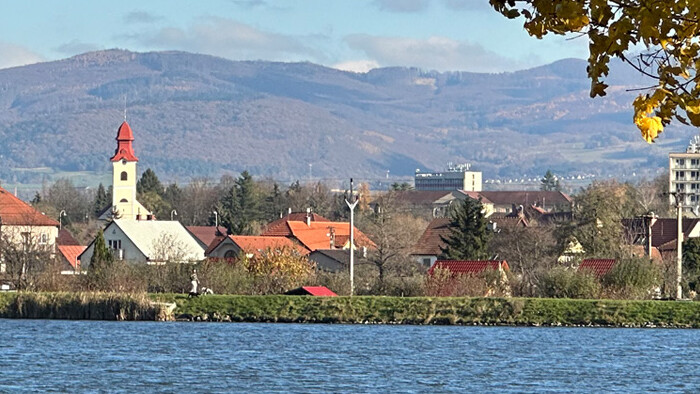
[154,295,700,328]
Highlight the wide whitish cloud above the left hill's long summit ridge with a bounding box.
[130,17,325,61]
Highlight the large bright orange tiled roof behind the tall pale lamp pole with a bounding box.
[287,221,376,252]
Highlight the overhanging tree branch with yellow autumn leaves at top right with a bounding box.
[490,0,700,143]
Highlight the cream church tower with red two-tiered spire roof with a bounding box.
[110,121,151,220]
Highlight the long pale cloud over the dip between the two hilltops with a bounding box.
[345,34,526,72]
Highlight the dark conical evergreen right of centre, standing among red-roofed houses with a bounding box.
[440,198,491,260]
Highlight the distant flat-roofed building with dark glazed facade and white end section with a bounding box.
[414,164,481,192]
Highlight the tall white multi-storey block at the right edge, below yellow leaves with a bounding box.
[668,135,700,211]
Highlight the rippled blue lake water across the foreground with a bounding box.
[0,320,700,393]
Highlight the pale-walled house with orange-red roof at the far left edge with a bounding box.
[0,187,59,272]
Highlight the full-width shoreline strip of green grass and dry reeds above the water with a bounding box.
[0,293,700,328]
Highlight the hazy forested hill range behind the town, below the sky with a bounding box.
[0,50,694,185]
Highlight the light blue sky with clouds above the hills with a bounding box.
[0,0,587,72]
